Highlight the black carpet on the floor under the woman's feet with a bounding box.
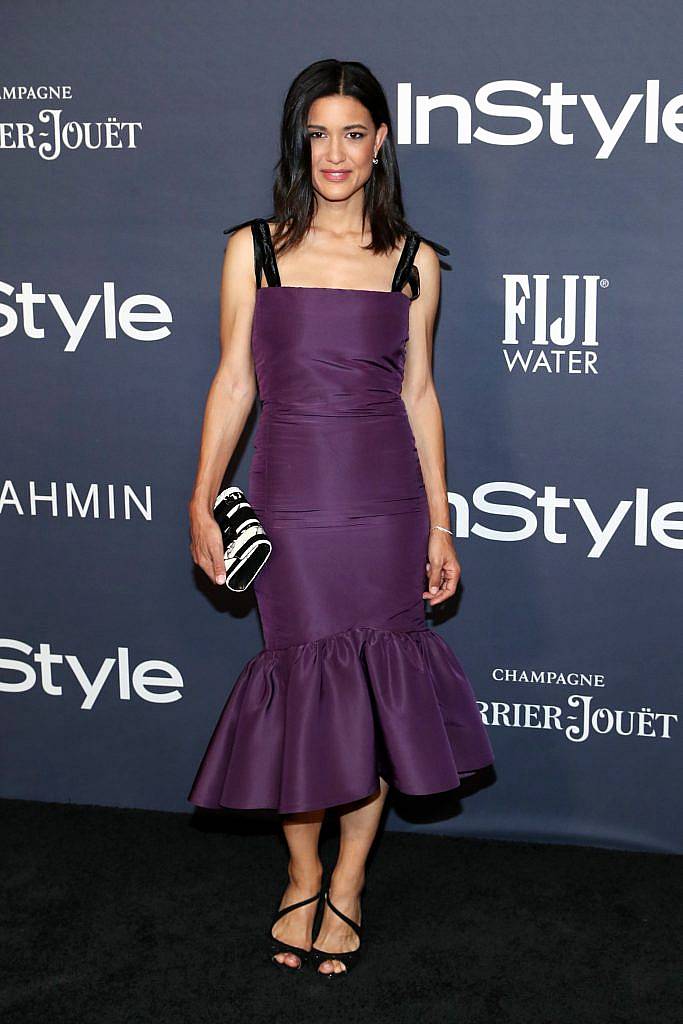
[0,800,683,1024]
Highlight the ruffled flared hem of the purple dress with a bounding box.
[187,627,494,814]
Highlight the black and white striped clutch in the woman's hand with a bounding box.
[213,486,272,591]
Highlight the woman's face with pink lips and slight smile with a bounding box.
[306,96,388,202]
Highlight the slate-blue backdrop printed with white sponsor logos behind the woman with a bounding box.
[0,0,683,852]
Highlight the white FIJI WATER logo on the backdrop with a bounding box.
[502,273,609,374]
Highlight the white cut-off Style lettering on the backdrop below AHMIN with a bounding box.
[0,637,183,711]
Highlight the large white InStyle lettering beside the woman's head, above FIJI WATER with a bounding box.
[396,78,683,160]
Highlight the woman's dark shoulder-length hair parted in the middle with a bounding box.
[223,58,449,262]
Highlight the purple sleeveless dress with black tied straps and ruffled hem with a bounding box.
[187,218,494,814]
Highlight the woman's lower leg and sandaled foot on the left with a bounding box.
[272,810,325,968]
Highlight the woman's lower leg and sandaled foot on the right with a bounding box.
[315,776,389,974]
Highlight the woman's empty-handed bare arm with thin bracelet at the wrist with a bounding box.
[401,244,461,605]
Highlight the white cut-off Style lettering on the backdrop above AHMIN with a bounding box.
[0,281,173,352]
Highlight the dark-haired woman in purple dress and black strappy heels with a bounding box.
[188,60,493,978]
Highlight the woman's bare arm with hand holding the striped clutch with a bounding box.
[188,226,257,583]
